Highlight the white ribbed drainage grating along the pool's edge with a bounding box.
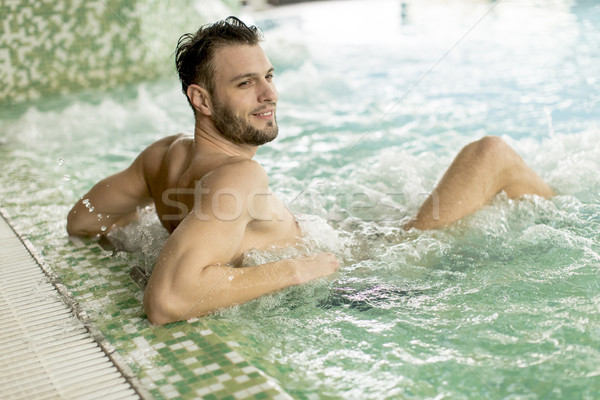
[0,214,140,399]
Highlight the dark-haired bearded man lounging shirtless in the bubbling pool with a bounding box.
[67,17,552,324]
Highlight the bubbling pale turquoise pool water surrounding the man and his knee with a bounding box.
[0,0,600,399]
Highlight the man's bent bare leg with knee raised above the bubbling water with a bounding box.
[405,136,554,229]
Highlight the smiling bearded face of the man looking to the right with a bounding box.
[211,45,279,146]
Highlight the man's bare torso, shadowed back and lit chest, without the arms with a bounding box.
[146,135,301,260]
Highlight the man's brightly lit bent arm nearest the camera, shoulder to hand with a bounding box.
[144,161,339,325]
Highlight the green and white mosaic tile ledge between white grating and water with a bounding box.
[0,192,291,400]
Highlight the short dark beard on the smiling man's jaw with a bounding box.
[212,99,279,146]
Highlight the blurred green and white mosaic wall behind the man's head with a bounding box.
[0,0,238,107]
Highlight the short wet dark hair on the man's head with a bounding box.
[175,17,262,105]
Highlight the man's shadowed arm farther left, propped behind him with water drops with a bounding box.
[67,137,166,237]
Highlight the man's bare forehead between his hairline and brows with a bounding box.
[214,45,273,79]
